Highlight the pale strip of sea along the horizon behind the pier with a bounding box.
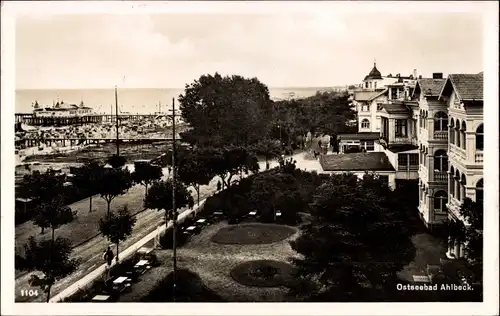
[15,87,331,114]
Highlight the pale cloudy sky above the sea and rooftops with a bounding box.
[15,11,483,89]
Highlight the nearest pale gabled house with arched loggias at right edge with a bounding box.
[438,72,484,258]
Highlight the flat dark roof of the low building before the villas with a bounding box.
[320,152,395,171]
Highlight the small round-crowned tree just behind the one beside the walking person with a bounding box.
[96,168,132,216]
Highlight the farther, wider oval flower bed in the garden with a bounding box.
[211,223,295,245]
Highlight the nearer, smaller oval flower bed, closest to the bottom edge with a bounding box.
[231,260,294,287]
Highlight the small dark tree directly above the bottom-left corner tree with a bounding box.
[34,195,76,240]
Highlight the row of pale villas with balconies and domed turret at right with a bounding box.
[344,66,484,258]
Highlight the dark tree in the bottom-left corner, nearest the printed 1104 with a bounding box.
[15,237,80,302]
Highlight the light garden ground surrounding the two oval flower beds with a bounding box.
[120,222,298,302]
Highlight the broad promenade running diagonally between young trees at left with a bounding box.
[15,153,321,302]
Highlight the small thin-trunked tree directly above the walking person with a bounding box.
[99,205,136,262]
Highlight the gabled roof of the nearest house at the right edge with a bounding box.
[439,72,484,101]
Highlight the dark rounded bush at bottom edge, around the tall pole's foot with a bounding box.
[141,269,224,302]
